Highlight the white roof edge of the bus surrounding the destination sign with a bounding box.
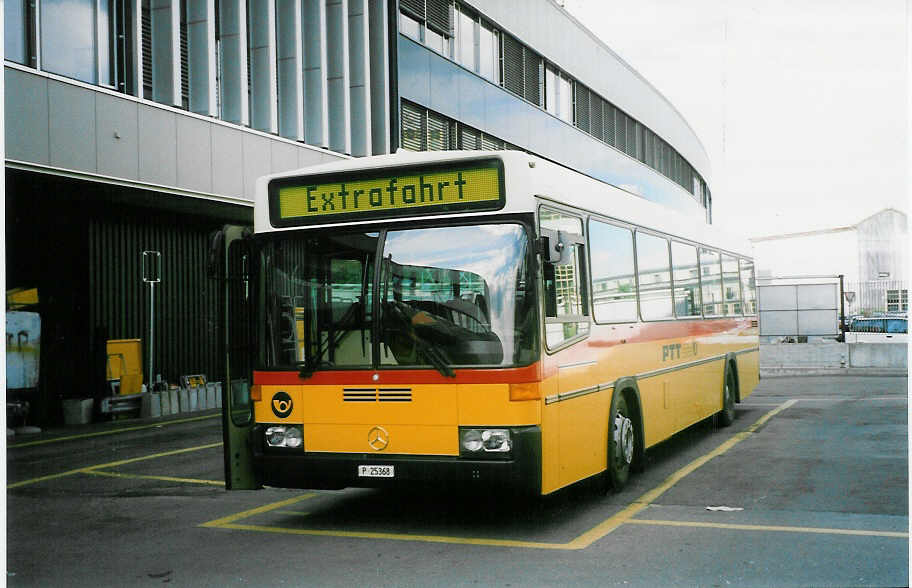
[254,150,751,256]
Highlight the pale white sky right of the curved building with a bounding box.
[558,0,912,237]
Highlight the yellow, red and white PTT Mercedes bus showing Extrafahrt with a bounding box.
[219,151,758,495]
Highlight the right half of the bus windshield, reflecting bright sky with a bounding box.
[380,224,539,368]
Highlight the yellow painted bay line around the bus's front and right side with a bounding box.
[201,400,796,550]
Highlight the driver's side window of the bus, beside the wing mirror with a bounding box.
[539,208,589,349]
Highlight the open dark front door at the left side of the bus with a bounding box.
[209,225,260,490]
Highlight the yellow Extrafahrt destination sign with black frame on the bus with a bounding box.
[269,160,504,226]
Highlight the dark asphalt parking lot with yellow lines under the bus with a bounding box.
[7,376,909,586]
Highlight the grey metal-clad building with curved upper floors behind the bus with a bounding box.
[3,0,712,422]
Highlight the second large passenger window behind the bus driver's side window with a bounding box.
[636,231,674,321]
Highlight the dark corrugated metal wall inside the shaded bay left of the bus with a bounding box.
[89,212,224,383]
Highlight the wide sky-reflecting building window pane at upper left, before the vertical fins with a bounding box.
[41,0,96,84]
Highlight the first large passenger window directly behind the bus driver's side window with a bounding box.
[589,221,636,323]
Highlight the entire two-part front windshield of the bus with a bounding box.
[262,224,538,375]
